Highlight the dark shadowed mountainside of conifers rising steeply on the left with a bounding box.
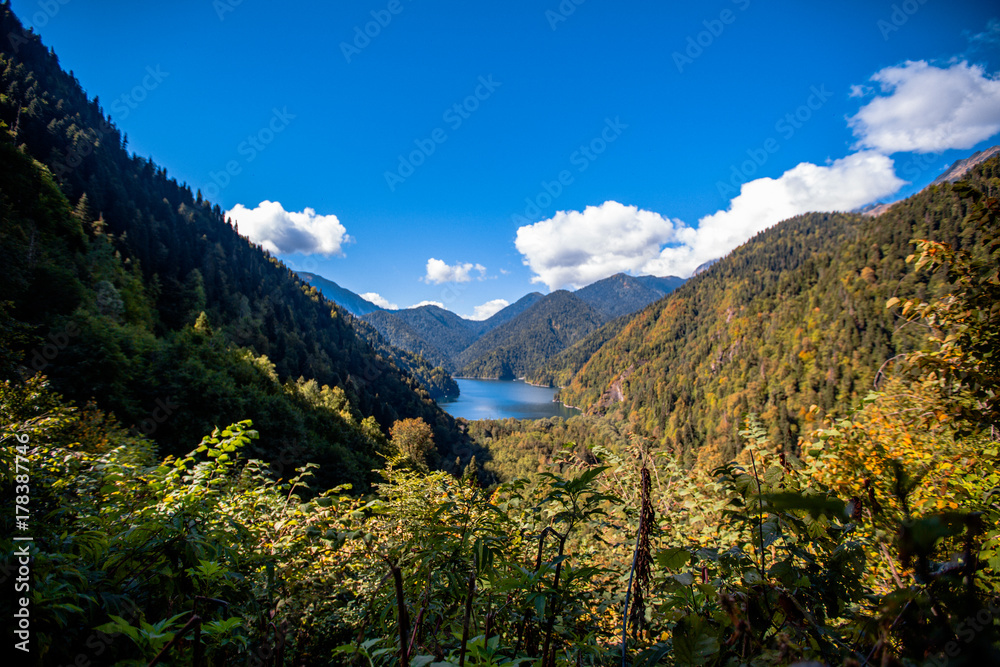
[0,3,464,488]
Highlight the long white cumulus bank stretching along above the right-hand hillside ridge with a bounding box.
[516,151,903,289]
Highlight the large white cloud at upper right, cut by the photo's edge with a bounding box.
[848,60,1000,154]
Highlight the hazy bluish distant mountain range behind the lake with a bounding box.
[299,272,684,379]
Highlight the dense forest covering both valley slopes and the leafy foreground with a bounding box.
[0,2,1000,667]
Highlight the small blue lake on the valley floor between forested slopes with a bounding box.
[438,378,580,420]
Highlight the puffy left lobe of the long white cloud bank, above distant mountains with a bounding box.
[514,201,694,289]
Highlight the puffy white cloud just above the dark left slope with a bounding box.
[225,201,353,256]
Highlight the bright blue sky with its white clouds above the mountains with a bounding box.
[12,0,1000,317]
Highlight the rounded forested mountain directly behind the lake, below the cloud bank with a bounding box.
[458,290,607,379]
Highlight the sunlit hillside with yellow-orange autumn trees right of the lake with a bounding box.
[561,159,1000,462]
